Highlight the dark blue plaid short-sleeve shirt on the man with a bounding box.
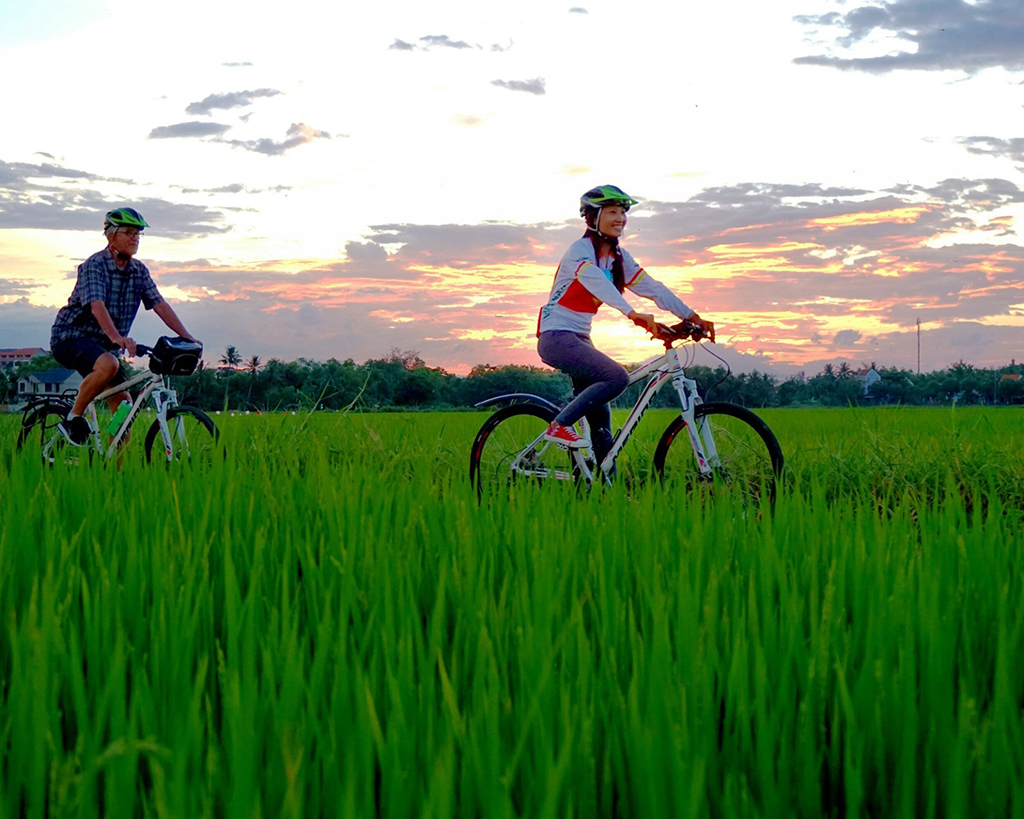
[50,248,164,349]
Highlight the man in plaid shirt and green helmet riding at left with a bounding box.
[50,208,198,446]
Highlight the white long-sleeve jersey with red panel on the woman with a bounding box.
[537,236,694,336]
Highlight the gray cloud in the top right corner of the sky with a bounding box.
[794,0,1024,73]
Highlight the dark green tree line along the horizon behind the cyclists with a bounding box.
[0,347,1024,412]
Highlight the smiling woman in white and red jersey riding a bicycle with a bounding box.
[537,185,715,463]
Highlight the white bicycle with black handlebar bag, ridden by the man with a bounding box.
[17,336,220,464]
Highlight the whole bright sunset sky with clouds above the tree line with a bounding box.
[0,0,1024,377]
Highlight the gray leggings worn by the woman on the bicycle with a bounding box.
[537,330,630,460]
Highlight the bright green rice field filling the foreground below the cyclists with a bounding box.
[0,407,1024,819]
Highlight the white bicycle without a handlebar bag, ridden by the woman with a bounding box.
[469,321,783,501]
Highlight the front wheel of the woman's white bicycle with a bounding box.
[654,402,784,504]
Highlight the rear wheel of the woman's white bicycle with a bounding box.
[469,403,573,497]
